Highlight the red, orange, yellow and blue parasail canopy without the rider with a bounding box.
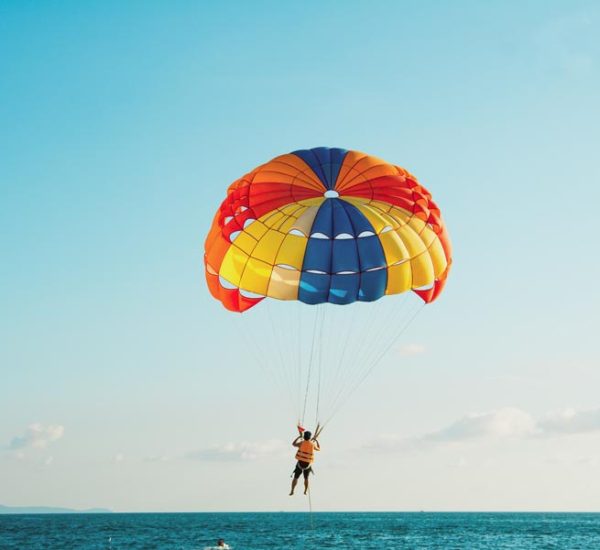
[205,147,452,312]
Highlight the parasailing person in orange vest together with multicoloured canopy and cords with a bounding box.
[204,147,452,495]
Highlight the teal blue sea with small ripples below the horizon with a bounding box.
[0,512,600,550]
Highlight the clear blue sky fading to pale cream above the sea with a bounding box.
[0,1,600,510]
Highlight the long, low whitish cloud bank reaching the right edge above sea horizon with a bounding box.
[367,407,600,451]
